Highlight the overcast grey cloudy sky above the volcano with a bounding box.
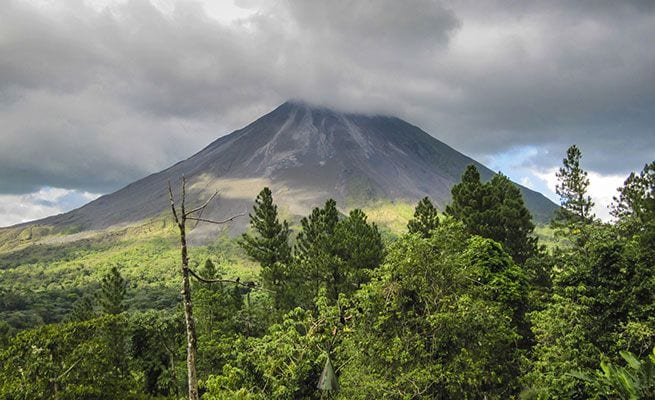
[0,0,655,226]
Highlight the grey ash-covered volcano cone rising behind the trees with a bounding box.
[29,102,556,236]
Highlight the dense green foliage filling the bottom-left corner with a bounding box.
[0,316,135,399]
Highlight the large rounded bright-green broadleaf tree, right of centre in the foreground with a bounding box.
[340,220,520,399]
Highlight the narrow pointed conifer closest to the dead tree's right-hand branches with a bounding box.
[239,187,291,309]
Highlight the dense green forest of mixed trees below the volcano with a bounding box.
[0,146,655,400]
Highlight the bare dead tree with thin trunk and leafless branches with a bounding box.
[168,177,245,400]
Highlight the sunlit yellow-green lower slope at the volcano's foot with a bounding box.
[0,202,555,328]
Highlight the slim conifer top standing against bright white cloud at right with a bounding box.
[554,145,596,229]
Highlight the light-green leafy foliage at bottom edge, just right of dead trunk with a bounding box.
[203,290,342,400]
